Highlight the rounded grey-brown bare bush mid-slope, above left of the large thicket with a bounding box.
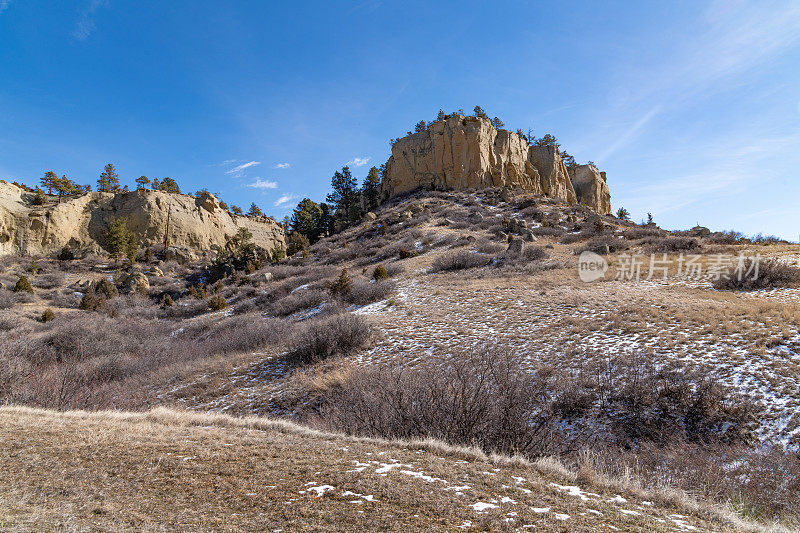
[292,313,374,364]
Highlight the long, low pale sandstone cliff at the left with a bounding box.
[0,180,285,255]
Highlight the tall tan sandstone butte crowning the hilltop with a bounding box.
[381,115,610,212]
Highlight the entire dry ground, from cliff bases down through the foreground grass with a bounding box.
[0,188,800,530]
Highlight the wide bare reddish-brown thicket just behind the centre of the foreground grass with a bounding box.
[322,349,576,457]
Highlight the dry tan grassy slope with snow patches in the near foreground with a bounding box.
[0,407,736,531]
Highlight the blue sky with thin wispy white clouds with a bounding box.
[0,0,800,240]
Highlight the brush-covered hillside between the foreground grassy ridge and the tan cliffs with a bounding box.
[0,184,800,527]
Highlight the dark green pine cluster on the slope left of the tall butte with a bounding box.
[286,165,386,252]
